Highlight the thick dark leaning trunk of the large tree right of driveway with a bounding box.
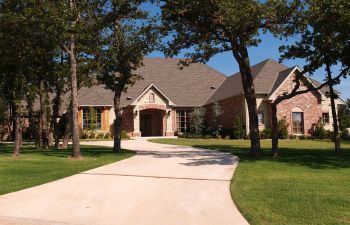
[232,43,261,157]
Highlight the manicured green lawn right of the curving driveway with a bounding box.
[153,139,350,225]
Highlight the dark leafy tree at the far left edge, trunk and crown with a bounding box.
[0,0,52,156]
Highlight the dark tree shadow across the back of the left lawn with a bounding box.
[0,144,130,158]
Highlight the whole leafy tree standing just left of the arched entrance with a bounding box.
[97,0,158,152]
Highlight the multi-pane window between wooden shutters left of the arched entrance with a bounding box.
[83,107,102,130]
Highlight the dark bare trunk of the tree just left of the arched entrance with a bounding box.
[113,91,122,153]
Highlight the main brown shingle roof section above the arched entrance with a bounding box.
[78,58,226,107]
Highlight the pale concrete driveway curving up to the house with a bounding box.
[0,139,248,225]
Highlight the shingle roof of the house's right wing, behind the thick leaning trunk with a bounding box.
[207,59,291,104]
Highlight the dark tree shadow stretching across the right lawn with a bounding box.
[193,144,350,169]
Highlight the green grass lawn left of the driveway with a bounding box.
[0,145,134,195]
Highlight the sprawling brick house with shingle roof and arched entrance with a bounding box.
[72,58,342,137]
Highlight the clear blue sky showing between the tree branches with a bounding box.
[147,5,350,100]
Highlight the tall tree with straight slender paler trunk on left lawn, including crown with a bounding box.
[40,0,105,159]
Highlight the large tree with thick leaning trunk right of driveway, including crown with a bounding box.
[161,0,299,156]
